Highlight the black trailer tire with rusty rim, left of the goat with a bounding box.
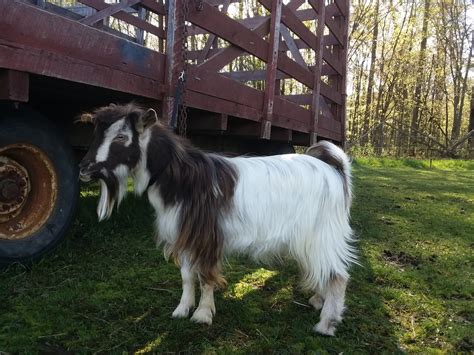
[0,109,79,265]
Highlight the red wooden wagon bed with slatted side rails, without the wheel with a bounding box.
[0,0,349,145]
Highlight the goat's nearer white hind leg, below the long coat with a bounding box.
[314,275,347,336]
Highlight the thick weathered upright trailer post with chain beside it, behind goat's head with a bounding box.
[162,0,188,124]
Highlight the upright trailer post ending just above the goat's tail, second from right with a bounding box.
[309,0,326,145]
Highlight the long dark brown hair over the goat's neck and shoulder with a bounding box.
[147,125,237,287]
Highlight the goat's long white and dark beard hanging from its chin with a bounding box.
[97,165,128,222]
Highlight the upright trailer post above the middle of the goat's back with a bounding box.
[260,0,283,139]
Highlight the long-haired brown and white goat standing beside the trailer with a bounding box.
[80,104,356,335]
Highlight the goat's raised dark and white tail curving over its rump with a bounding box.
[305,141,352,210]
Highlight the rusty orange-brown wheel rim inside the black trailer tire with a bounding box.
[0,144,58,240]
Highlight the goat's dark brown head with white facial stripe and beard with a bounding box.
[79,104,158,220]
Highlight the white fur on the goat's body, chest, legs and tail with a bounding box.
[104,134,356,335]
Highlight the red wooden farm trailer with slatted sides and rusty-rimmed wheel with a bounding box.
[0,0,349,264]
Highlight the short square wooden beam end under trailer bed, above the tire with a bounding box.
[0,69,30,102]
